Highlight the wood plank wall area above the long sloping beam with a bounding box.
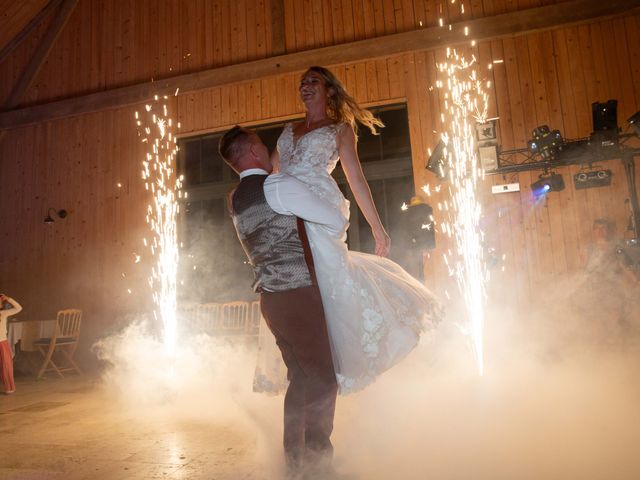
[0,0,572,109]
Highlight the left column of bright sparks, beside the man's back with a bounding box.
[135,95,182,356]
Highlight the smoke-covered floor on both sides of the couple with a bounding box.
[0,318,640,480]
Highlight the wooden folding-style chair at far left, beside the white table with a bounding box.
[33,309,82,378]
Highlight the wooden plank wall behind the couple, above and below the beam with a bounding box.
[0,5,640,360]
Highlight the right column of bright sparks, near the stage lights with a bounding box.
[438,49,488,375]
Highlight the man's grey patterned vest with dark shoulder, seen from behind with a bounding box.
[231,175,314,292]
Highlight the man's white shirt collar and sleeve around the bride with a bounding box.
[240,168,349,236]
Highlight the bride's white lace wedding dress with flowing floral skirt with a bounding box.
[252,124,444,394]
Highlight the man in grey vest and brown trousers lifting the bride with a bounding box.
[219,126,347,478]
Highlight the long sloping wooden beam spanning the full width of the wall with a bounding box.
[0,0,640,130]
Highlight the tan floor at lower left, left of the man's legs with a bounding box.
[0,376,269,480]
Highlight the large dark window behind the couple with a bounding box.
[178,105,422,303]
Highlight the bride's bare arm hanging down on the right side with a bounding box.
[338,125,391,257]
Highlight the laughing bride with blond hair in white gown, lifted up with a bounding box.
[258,67,443,394]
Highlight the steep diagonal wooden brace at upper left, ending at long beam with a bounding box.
[4,0,78,110]
